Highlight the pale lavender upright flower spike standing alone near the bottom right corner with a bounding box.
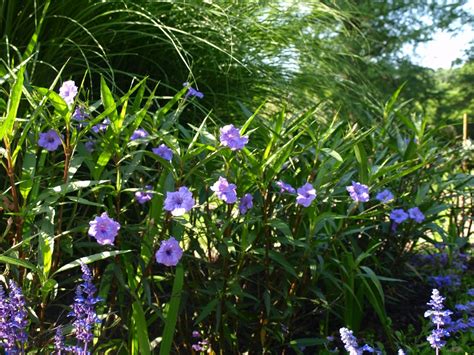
[424,289,453,351]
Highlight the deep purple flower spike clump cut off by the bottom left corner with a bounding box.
[0,280,28,354]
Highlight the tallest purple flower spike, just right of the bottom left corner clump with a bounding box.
[68,263,101,354]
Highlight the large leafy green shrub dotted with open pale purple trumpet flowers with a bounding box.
[0,64,472,354]
